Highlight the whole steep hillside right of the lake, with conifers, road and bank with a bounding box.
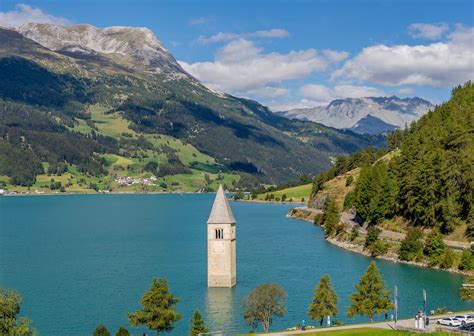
[302,82,474,274]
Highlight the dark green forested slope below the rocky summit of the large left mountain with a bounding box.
[0,29,385,186]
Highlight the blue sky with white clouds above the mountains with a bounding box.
[0,0,474,110]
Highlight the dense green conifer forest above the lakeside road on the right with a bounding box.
[313,82,474,239]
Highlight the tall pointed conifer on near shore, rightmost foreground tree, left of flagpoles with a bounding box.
[347,262,393,322]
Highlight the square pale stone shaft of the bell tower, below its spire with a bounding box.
[207,223,237,287]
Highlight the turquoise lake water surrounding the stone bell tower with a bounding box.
[0,194,473,336]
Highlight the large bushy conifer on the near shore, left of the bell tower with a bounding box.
[128,279,181,336]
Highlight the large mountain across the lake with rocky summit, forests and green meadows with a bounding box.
[0,23,384,189]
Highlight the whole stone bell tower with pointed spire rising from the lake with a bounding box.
[207,185,237,287]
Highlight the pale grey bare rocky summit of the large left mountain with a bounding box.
[16,23,185,74]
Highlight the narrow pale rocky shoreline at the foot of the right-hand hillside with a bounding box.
[286,210,474,276]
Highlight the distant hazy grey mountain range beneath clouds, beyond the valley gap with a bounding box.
[276,96,434,134]
